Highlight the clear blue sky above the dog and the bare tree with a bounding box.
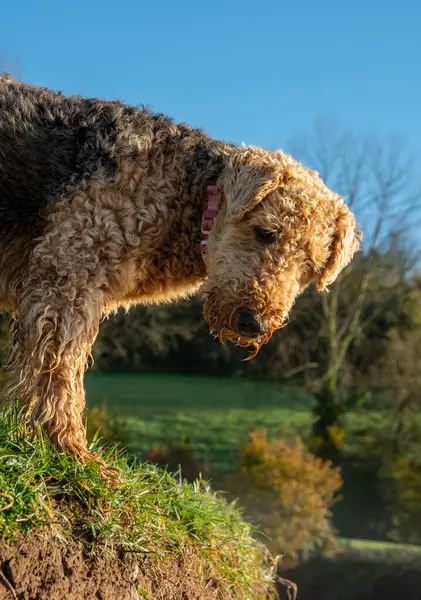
[0,0,421,154]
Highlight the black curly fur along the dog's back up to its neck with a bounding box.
[0,77,223,242]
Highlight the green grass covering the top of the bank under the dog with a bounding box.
[0,413,276,598]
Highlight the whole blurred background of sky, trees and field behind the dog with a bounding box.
[0,0,421,600]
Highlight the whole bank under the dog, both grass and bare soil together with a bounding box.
[0,415,271,600]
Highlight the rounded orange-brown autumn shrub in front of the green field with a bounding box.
[226,432,342,565]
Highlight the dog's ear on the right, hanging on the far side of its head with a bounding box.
[317,202,362,291]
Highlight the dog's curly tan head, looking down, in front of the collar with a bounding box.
[201,147,361,356]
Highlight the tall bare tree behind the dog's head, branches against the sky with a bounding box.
[290,121,421,458]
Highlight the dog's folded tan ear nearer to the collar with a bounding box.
[224,161,280,221]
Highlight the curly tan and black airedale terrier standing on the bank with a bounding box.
[0,78,360,460]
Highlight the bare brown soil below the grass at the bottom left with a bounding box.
[0,532,222,600]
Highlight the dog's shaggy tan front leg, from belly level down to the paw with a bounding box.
[10,266,102,460]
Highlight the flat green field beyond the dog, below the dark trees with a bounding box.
[86,373,311,469]
